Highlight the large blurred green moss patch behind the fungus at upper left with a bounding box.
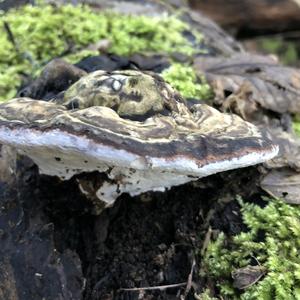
[0,1,202,100]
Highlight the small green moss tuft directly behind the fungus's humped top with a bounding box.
[161,63,213,100]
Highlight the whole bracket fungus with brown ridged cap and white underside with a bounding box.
[0,71,278,210]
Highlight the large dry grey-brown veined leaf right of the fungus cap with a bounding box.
[195,54,300,121]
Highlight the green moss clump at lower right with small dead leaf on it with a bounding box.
[204,199,300,300]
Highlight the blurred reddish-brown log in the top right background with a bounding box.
[189,0,300,35]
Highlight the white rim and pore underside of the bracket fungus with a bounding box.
[0,128,278,206]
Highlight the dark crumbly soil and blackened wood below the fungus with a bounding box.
[0,150,257,300]
